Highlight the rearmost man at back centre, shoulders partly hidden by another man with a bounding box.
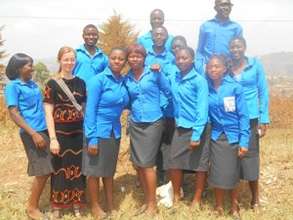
[137,9,173,51]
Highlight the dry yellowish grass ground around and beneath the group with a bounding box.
[0,95,293,220]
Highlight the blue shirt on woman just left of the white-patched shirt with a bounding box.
[171,69,208,141]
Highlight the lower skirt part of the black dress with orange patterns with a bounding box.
[51,133,86,208]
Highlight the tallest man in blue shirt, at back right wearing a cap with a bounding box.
[195,0,242,74]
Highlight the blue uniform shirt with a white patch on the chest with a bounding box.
[208,75,250,148]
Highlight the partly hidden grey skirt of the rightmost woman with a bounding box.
[240,119,259,181]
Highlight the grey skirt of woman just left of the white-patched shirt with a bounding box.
[164,123,209,171]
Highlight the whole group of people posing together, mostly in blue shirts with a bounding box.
[5,0,269,219]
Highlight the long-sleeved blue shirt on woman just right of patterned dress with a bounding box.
[84,68,129,145]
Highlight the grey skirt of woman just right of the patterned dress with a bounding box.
[82,134,120,177]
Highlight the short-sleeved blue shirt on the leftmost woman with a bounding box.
[5,79,47,132]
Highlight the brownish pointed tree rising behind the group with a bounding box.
[98,12,138,54]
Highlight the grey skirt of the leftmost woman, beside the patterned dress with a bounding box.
[20,131,54,176]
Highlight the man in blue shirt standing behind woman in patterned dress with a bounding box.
[73,24,108,83]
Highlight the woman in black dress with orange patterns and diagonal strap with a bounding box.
[44,47,86,218]
